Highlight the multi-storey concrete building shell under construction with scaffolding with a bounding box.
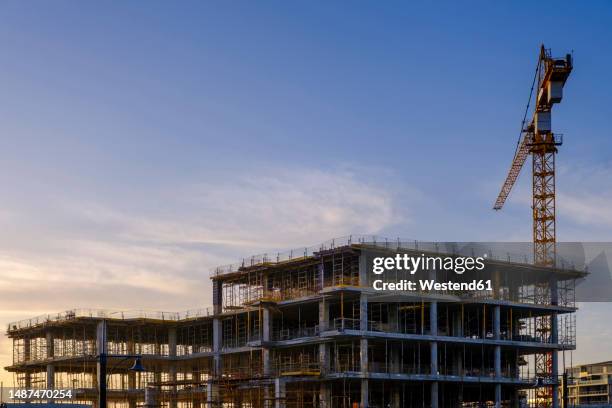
[7,237,584,408]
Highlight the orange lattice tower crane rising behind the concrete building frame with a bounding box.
[493,45,573,407]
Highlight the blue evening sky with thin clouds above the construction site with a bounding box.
[0,1,612,380]
